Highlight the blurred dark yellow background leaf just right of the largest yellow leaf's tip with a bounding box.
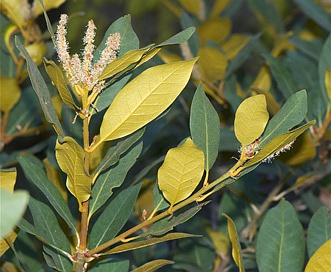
[198,47,228,82]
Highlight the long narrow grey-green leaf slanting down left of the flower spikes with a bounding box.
[15,37,63,136]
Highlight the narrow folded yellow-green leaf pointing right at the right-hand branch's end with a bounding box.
[244,121,315,168]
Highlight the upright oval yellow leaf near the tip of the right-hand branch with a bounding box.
[234,94,269,146]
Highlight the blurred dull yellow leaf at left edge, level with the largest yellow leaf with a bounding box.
[0,77,22,112]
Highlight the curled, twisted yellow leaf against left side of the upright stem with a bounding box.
[55,137,91,209]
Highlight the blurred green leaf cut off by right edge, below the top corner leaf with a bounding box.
[318,35,331,105]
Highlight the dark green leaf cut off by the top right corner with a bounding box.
[294,0,331,31]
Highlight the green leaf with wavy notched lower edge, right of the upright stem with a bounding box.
[89,141,143,217]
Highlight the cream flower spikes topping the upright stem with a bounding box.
[55,14,121,95]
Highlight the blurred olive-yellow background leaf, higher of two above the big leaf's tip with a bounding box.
[197,18,231,46]
